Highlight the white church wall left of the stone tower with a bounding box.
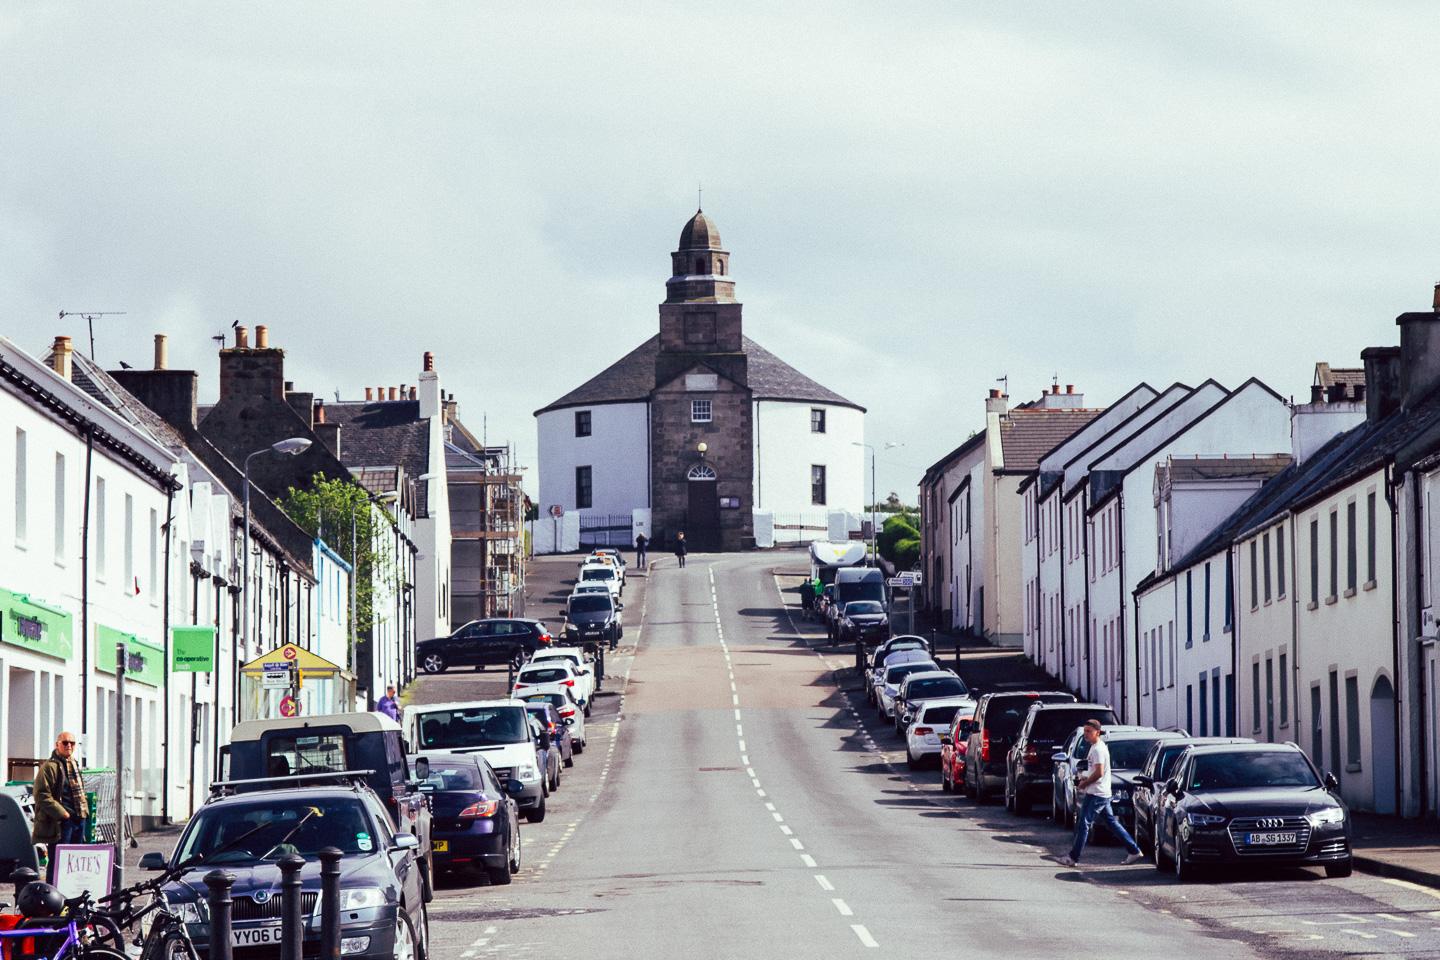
[536,403,650,517]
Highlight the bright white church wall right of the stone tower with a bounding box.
[760,400,858,522]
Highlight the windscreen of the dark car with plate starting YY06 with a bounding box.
[177,794,379,864]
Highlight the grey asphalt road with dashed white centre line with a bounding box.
[418,553,1440,960]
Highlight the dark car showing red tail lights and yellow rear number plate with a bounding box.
[412,753,524,884]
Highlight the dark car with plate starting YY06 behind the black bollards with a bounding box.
[140,782,429,960]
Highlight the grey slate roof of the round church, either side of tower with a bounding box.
[535,334,864,414]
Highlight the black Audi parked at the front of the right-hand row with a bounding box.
[1155,743,1352,879]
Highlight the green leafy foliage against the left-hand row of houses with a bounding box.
[279,474,393,633]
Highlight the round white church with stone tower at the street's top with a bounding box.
[536,210,865,550]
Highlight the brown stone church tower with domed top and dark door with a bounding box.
[649,210,755,550]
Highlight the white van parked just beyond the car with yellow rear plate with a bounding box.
[405,699,546,823]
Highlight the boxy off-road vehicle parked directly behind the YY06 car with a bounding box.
[223,712,435,901]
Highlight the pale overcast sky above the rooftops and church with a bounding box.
[0,0,1440,501]
